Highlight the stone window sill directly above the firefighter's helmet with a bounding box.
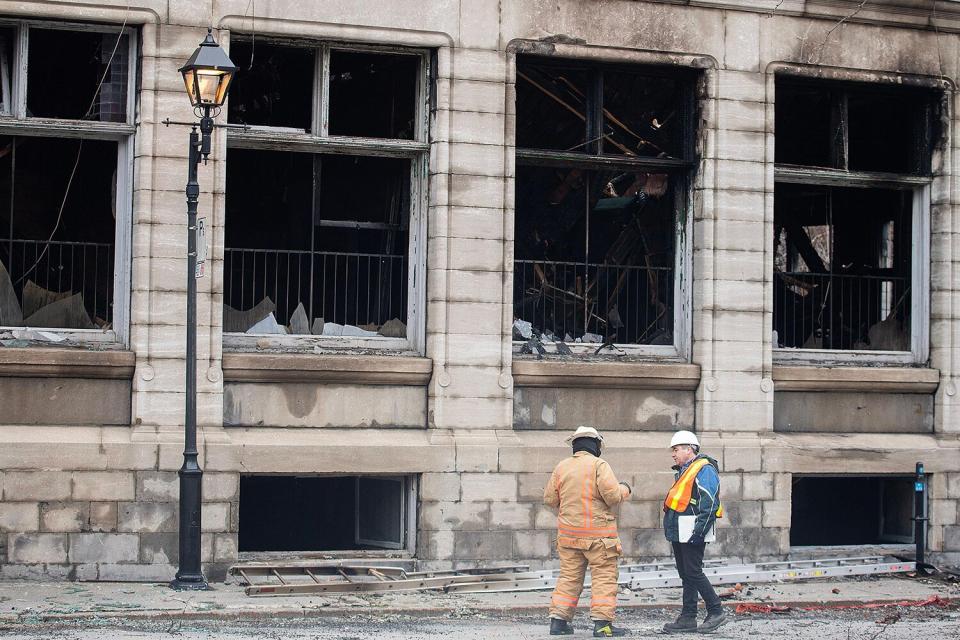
[513,360,700,391]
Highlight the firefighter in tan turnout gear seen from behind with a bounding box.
[543,427,631,638]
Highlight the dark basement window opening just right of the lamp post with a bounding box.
[239,475,416,552]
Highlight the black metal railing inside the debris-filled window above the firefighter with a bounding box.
[513,260,674,344]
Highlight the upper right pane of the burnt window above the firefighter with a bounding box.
[603,71,686,158]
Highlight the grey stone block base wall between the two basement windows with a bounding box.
[417,458,790,568]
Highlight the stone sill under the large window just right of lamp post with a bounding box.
[223,353,433,386]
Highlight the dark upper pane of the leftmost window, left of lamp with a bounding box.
[27,27,130,122]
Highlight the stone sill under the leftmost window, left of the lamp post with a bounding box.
[0,347,136,380]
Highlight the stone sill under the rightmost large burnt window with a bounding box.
[773,365,940,393]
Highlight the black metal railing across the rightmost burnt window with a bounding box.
[773,271,911,351]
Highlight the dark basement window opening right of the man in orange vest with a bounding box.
[790,475,914,546]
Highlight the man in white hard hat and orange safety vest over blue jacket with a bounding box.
[663,431,727,633]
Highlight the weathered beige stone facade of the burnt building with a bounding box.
[0,0,960,581]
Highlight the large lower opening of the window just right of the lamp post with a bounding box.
[224,149,410,338]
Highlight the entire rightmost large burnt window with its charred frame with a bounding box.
[773,74,939,364]
